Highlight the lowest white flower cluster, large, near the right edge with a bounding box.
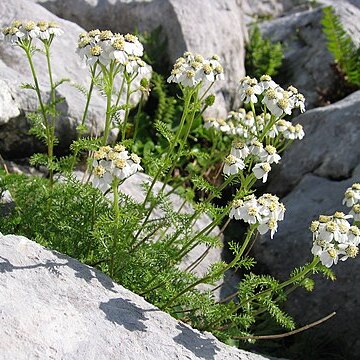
[310,212,360,267]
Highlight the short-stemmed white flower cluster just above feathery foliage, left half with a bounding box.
[93,145,142,192]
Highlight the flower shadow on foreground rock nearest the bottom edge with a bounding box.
[174,323,220,360]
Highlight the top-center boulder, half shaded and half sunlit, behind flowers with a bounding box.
[36,0,248,116]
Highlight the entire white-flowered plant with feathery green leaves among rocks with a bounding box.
[0,21,360,348]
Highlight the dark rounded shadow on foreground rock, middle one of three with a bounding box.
[99,298,148,331]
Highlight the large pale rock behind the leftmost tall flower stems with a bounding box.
[0,0,149,158]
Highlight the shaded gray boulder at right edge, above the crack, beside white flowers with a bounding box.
[268,91,360,195]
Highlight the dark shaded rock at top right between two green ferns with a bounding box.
[261,1,360,108]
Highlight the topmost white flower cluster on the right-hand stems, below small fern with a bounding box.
[239,75,305,118]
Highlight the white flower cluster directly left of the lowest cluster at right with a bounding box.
[229,194,285,238]
